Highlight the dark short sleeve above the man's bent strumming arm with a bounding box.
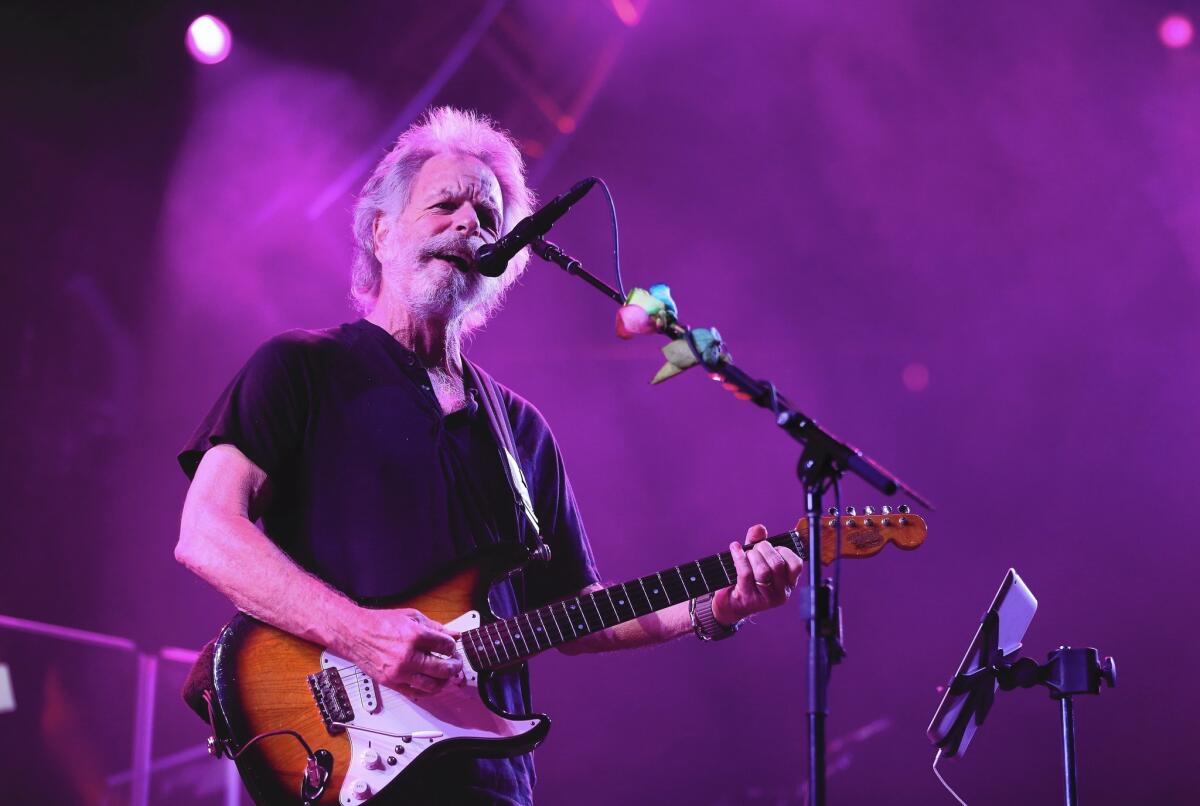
[179,335,308,479]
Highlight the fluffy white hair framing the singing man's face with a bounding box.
[350,107,534,331]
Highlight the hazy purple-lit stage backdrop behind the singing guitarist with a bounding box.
[0,0,1200,805]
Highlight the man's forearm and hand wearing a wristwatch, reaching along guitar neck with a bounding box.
[559,524,803,655]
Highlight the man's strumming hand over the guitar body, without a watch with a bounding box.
[347,607,462,696]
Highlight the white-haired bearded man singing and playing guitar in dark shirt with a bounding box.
[175,108,800,804]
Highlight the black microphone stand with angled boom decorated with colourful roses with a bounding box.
[530,237,934,806]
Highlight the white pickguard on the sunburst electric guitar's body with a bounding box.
[320,610,542,806]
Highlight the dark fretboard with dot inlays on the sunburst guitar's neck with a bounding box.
[462,530,806,669]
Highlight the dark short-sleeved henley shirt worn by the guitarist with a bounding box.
[179,319,599,804]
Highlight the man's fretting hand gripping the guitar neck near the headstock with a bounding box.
[713,524,804,626]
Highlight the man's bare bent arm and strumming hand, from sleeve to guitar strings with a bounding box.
[175,445,462,693]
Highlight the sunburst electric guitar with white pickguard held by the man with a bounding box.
[212,506,926,806]
